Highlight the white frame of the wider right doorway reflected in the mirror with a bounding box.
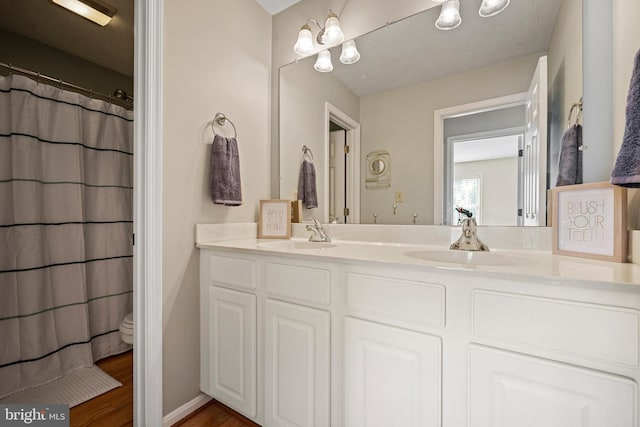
[433,92,527,225]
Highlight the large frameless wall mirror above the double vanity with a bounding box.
[279,0,582,225]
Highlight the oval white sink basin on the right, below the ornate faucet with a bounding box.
[405,250,535,267]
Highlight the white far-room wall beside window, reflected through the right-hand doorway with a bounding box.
[453,157,518,225]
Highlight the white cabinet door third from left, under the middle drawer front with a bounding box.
[344,318,442,427]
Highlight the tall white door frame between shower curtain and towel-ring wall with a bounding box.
[133,0,163,426]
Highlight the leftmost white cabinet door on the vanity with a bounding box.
[208,286,257,417]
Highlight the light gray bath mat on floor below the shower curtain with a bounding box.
[0,365,122,407]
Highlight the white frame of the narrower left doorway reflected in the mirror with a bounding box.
[322,102,360,224]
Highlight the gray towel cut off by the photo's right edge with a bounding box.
[611,51,640,188]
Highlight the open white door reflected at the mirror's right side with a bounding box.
[522,56,547,226]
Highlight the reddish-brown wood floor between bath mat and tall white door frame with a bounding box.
[69,351,133,427]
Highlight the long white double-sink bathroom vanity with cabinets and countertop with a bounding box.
[198,224,640,427]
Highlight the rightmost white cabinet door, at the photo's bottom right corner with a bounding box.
[468,345,637,427]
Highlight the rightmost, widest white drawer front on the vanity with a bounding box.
[472,290,640,367]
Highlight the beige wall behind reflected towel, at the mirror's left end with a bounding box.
[280,58,360,222]
